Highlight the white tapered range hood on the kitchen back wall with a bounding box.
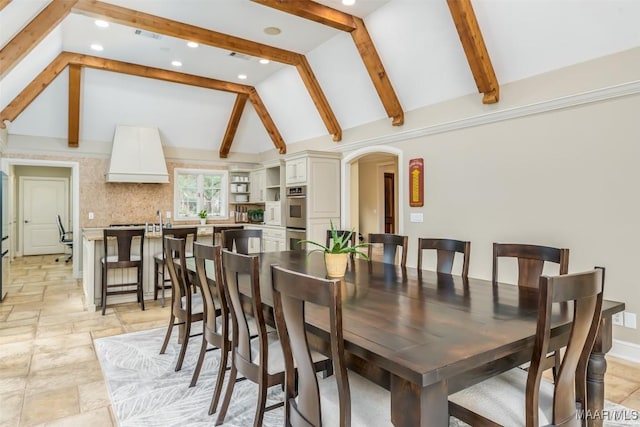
[105,125,169,184]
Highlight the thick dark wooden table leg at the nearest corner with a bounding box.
[391,374,449,427]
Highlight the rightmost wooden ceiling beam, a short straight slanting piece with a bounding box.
[447,0,500,104]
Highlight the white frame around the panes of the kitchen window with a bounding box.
[173,168,229,221]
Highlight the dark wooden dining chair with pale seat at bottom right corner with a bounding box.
[449,268,604,427]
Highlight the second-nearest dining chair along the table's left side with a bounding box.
[216,250,330,427]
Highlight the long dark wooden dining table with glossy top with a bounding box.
[190,251,625,426]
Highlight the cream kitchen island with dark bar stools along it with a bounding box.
[82,223,243,311]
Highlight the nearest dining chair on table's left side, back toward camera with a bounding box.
[271,265,391,427]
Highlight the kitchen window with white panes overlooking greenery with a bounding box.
[174,169,228,219]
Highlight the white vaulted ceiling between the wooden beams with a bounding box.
[0,0,640,157]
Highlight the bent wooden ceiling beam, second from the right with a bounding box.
[251,0,404,126]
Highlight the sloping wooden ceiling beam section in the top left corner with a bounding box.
[0,0,77,78]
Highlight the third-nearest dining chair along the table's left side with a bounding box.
[190,242,231,415]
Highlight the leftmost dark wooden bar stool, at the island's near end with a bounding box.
[100,228,144,316]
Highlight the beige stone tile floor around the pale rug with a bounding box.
[0,255,640,427]
